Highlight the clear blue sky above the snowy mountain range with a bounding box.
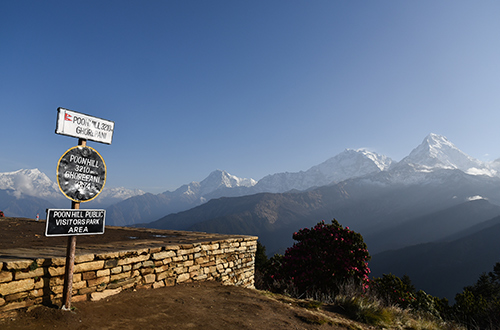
[0,0,500,193]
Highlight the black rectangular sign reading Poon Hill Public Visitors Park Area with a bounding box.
[45,209,106,236]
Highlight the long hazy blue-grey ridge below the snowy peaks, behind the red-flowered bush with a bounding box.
[142,165,500,253]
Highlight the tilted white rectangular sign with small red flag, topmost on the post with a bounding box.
[56,108,115,144]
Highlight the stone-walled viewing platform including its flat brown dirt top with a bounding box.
[0,218,257,317]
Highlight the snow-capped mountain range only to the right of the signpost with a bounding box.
[90,134,500,225]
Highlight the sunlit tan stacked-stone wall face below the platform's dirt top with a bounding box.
[0,236,257,317]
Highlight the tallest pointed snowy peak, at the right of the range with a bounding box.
[400,133,486,174]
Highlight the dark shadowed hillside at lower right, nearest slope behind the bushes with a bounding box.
[369,217,500,300]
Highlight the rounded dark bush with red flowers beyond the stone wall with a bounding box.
[275,220,370,293]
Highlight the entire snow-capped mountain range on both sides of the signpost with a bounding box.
[0,134,500,225]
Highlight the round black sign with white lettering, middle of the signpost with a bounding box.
[57,146,106,202]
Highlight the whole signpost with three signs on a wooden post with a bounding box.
[49,108,115,310]
